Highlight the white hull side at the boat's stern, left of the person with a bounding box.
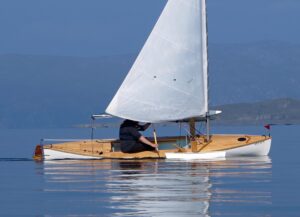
[44,149,102,160]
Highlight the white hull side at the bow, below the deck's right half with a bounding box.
[166,139,272,160]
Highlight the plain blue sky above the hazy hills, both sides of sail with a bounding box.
[0,0,300,56]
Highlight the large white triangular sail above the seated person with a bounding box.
[106,0,208,123]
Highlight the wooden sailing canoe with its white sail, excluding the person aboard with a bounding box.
[34,0,271,160]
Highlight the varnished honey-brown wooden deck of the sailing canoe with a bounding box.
[43,135,269,159]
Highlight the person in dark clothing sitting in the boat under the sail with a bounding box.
[119,120,157,153]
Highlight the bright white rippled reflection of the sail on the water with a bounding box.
[106,162,211,216]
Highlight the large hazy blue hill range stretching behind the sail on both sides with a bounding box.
[0,42,300,128]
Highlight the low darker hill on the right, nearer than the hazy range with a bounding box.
[215,99,300,125]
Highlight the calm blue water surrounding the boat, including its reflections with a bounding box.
[0,126,300,216]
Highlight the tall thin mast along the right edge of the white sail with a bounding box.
[201,0,210,142]
